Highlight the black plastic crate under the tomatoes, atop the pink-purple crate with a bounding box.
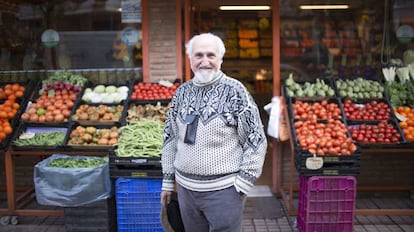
[295,148,361,176]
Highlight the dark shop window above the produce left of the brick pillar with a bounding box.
[0,0,142,71]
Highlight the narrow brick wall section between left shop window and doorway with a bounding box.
[144,0,181,82]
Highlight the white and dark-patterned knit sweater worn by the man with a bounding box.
[161,73,267,194]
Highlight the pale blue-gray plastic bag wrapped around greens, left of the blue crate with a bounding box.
[33,154,112,207]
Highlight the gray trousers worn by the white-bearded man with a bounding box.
[177,185,246,232]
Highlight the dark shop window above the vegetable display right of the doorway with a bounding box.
[280,0,414,78]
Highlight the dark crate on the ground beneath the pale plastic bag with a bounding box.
[63,197,117,232]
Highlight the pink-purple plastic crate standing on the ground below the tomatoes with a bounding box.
[297,176,356,232]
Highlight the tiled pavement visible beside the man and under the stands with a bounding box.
[0,186,414,232]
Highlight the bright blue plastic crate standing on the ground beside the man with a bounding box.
[115,178,164,232]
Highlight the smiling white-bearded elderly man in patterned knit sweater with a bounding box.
[161,33,267,232]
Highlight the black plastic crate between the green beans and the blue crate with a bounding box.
[109,149,162,178]
